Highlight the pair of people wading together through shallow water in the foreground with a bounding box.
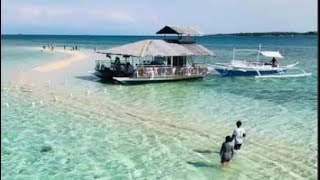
[220,121,246,166]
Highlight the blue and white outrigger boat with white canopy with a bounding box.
[214,45,311,78]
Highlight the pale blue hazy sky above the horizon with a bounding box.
[1,0,318,35]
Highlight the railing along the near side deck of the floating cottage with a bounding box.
[135,65,208,78]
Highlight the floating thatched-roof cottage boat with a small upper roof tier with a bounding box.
[94,26,215,84]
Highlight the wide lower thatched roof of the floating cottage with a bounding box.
[99,39,214,57]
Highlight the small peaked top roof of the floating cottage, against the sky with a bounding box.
[156,26,202,35]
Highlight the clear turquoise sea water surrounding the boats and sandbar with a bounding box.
[1,35,318,179]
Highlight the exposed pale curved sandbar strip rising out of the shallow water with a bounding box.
[33,49,88,72]
